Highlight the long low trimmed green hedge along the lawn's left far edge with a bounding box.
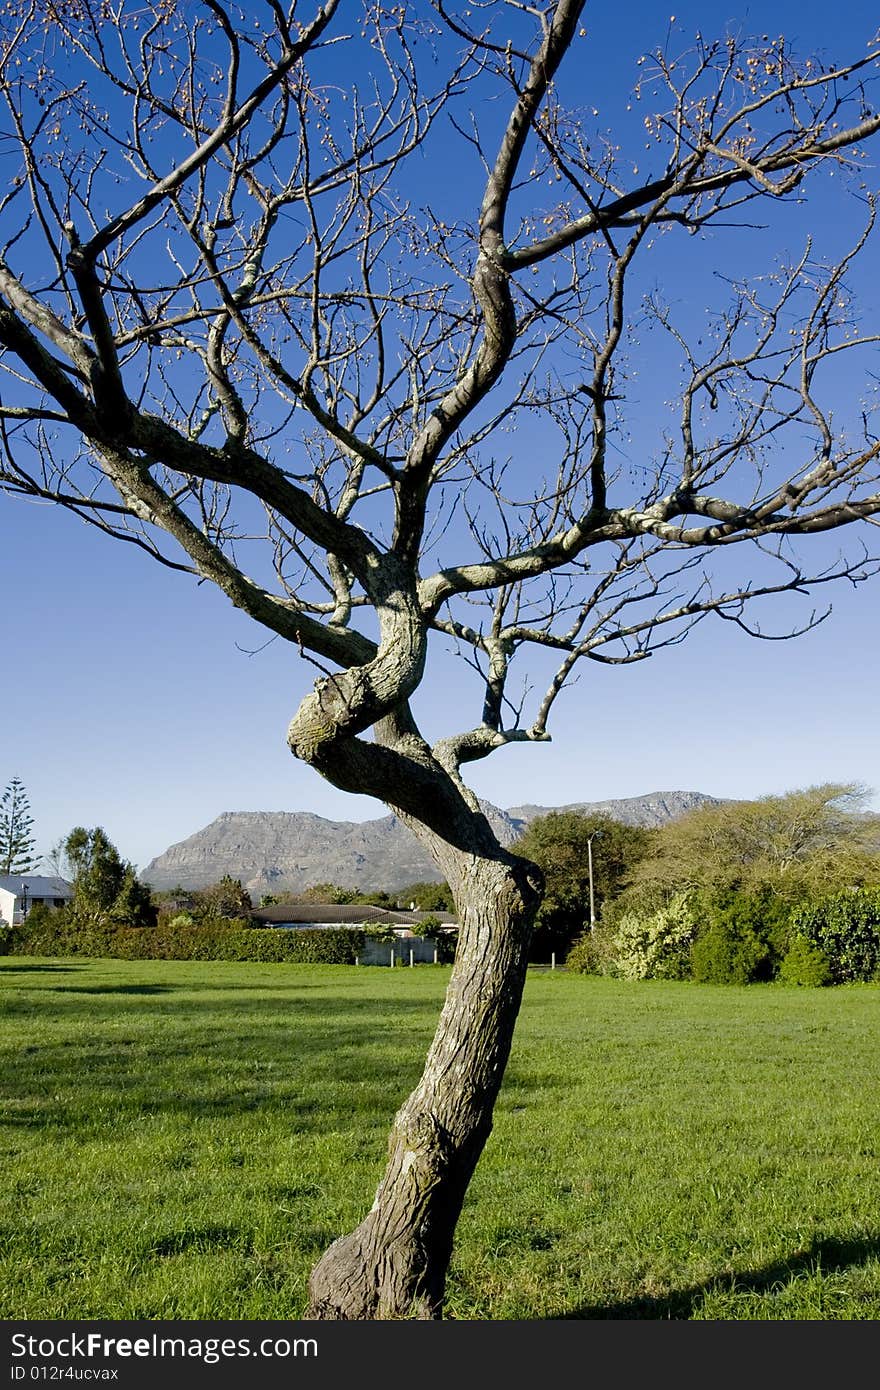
[0,908,364,965]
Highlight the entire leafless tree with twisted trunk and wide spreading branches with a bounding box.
[0,0,880,1319]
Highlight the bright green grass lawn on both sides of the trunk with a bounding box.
[0,958,880,1321]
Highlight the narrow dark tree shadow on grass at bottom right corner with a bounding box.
[549,1234,880,1322]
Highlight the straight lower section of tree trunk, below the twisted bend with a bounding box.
[306,815,539,1319]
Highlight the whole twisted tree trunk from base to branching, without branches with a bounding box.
[288,592,541,1321]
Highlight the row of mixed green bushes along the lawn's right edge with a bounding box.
[566,888,880,986]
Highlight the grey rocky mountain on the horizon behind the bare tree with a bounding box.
[140,791,717,902]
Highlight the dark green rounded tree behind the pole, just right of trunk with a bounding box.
[516,810,656,960]
